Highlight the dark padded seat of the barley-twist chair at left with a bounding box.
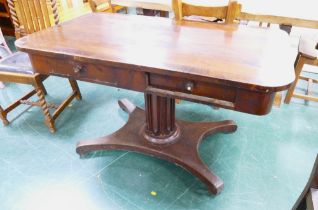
[0,52,34,74]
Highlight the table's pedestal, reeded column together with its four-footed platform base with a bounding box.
[76,93,237,194]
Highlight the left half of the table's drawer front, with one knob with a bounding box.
[30,55,146,92]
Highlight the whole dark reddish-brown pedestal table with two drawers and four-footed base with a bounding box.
[16,13,294,193]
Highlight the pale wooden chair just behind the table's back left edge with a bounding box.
[88,0,128,14]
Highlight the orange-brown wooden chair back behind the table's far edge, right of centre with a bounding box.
[172,0,241,24]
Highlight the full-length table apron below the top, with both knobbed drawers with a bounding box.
[29,54,275,115]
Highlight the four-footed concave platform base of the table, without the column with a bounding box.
[76,100,237,194]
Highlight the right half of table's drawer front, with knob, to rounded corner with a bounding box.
[148,74,275,115]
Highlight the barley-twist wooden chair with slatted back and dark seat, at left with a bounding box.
[0,0,81,132]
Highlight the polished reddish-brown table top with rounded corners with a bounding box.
[16,14,294,92]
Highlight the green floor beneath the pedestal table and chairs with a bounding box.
[0,37,318,210]
